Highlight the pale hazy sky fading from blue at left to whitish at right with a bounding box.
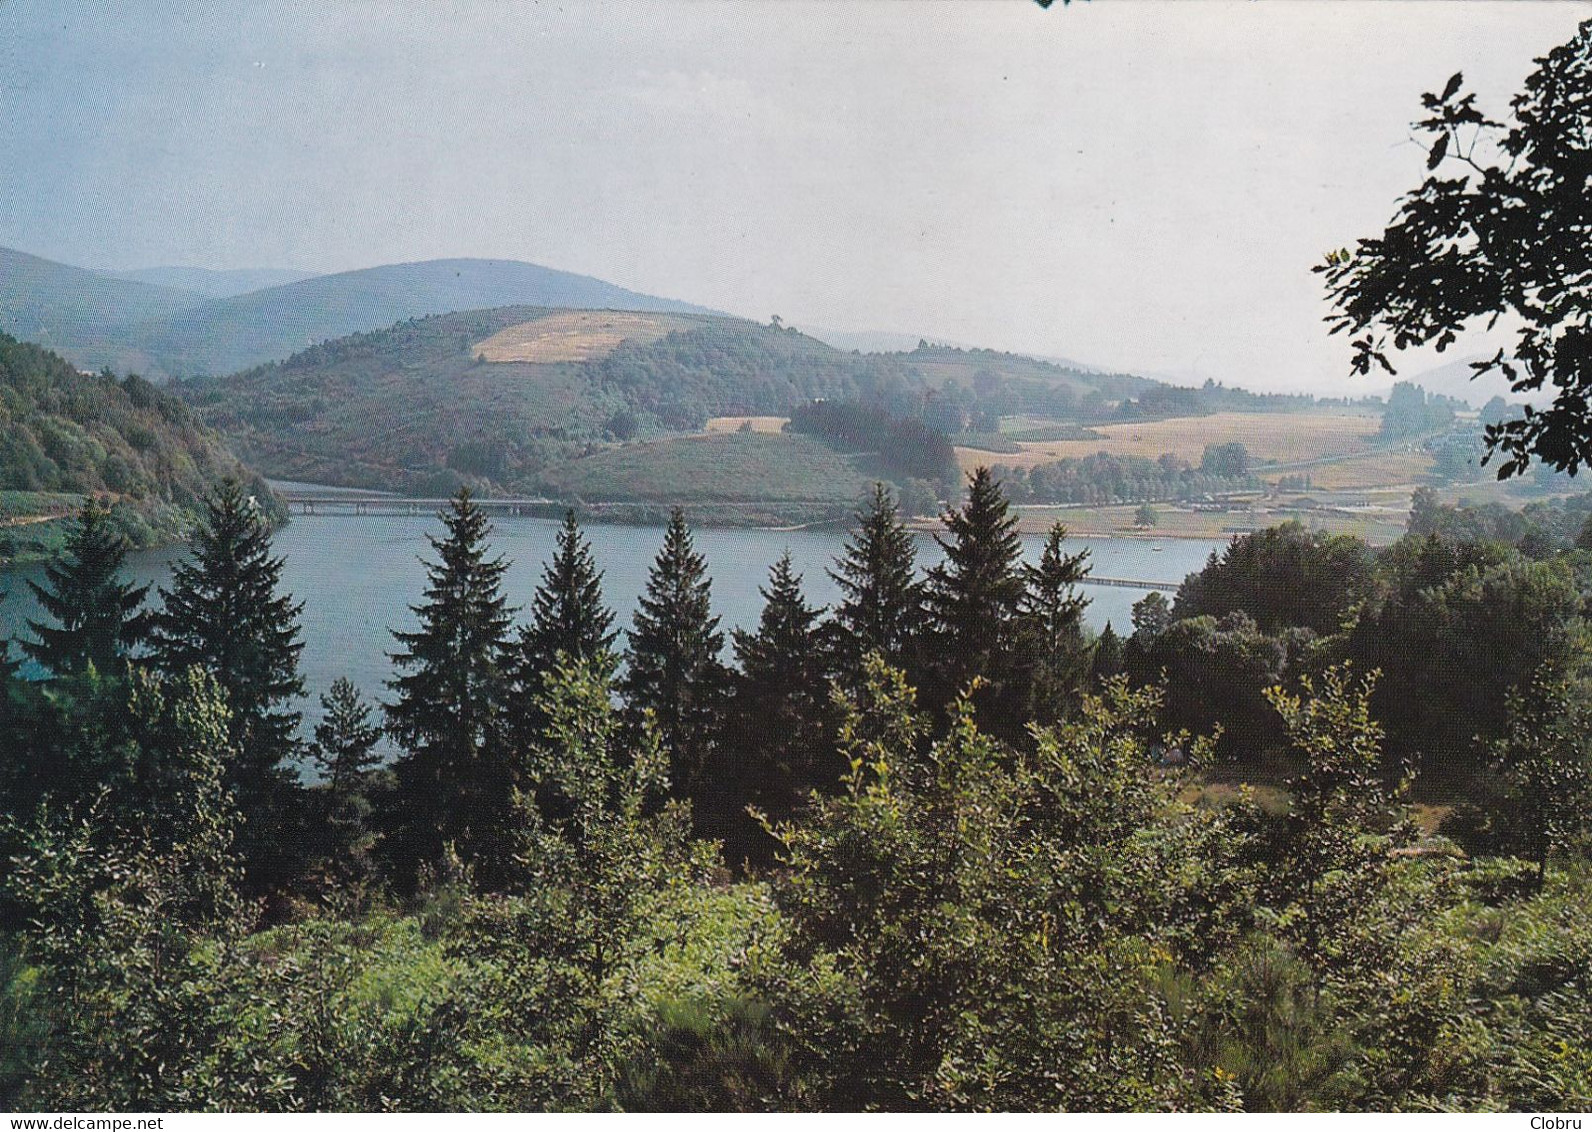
[0,0,1592,392]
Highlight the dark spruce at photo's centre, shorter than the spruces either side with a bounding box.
[704,551,844,865]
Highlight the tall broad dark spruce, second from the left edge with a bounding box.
[150,479,304,882]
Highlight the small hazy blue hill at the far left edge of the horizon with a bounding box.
[0,248,205,369]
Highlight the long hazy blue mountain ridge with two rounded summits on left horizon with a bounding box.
[0,252,719,379]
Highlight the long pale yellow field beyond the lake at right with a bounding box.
[957,412,1380,468]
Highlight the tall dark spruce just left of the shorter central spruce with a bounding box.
[622,508,729,798]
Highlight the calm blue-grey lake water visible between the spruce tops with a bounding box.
[0,516,1226,745]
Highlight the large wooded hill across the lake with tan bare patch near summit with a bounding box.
[177,307,1161,500]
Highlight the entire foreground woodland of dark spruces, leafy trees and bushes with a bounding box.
[0,470,1592,1110]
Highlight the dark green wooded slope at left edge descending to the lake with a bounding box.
[0,334,280,562]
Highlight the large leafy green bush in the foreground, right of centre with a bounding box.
[753,658,1194,1110]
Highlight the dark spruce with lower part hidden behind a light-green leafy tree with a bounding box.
[508,511,618,753]
